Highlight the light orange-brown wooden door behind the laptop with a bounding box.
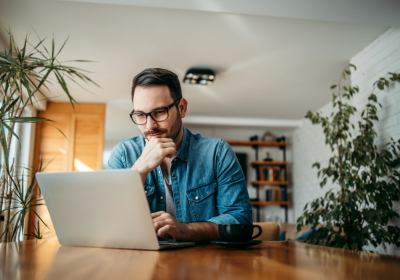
[28,102,105,239]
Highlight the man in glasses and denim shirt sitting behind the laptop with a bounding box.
[107,68,252,242]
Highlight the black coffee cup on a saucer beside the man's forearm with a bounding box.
[218,224,262,242]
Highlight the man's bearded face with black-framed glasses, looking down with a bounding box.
[133,86,182,140]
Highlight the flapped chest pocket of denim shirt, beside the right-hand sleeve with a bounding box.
[186,182,218,222]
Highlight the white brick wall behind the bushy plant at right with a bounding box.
[293,28,400,254]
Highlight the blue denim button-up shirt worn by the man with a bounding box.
[107,128,252,225]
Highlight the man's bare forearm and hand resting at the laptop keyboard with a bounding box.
[151,211,220,242]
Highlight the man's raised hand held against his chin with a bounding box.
[132,137,176,183]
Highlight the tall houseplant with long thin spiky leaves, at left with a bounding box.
[0,31,95,242]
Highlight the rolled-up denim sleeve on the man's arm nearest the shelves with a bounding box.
[208,140,253,225]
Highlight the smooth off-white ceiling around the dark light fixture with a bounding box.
[0,0,394,140]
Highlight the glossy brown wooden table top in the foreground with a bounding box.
[0,240,400,280]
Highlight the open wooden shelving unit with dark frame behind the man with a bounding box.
[226,140,290,222]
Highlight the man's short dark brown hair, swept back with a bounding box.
[131,68,182,101]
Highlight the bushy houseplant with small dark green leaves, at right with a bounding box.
[297,65,400,251]
